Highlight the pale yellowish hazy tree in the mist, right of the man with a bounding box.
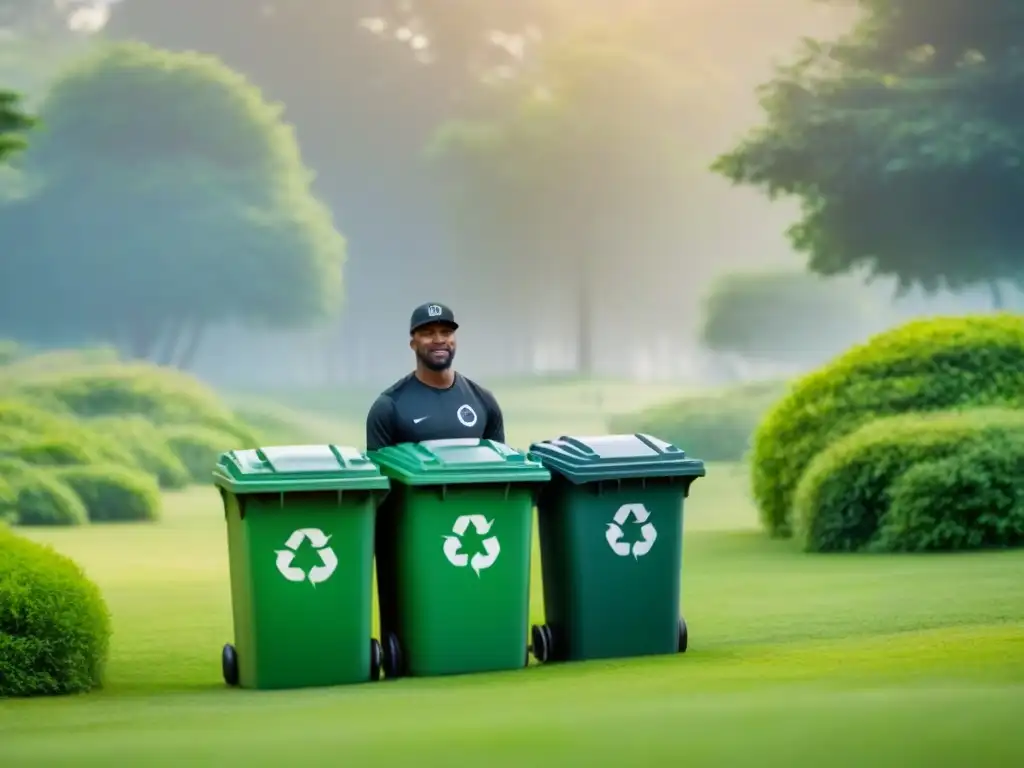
[431,19,720,375]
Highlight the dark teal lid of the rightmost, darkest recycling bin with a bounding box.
[527,433,705,484]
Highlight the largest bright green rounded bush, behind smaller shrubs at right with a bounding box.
[752,314,1024,536]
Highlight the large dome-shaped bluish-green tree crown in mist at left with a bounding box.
[0,43,345,366]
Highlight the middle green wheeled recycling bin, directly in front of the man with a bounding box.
[369,438,551,678]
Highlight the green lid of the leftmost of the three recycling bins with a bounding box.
[213,445,391,494]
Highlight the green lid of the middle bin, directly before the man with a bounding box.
[369,437,551,485]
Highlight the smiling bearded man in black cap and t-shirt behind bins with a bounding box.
[367,304,505,451]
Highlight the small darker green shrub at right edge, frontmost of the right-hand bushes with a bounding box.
[878,450,1024,552]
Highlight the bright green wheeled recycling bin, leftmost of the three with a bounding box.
[213,445,390,689]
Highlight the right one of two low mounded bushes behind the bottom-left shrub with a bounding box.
[56,465,160,522]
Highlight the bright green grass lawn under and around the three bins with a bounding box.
[0,465,1024,768]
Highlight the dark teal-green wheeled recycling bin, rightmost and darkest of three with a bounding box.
[528,434,705,662]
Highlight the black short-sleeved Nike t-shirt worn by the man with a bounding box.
[367,373,505,451]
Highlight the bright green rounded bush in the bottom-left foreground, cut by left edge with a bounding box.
[0,527,111,696]
